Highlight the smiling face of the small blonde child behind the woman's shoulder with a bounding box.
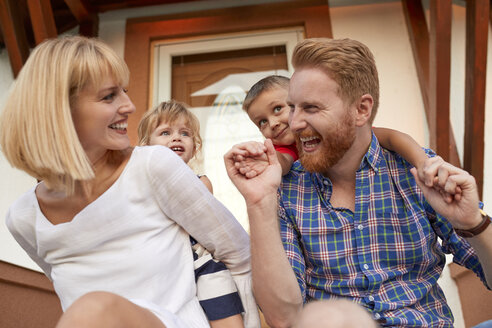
[149,116,195,163]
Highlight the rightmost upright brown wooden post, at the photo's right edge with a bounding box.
[464,0,490,196]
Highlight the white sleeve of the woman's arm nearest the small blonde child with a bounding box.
[146,146,260,328]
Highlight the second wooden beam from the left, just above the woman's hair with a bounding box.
[27,0,58,44]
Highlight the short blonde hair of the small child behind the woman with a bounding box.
[138,100,202,155]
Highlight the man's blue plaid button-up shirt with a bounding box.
[279,134,485,327]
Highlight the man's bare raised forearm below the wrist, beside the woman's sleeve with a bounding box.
[248,195,302,327]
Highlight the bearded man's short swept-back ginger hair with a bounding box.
[292,38,379,122]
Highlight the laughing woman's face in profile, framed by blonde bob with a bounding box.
[72,76,135,162]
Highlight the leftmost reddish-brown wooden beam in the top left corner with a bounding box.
[0,0,29,78]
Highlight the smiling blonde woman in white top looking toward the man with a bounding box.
[0,37,257,328]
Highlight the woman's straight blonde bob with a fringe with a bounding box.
[0,36,129,193]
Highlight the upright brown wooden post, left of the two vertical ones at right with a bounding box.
[428,0,451,161]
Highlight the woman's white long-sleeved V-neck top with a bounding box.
[7,146,259,328]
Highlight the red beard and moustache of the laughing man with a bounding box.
[296,111,355,173]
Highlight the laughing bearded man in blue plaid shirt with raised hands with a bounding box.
[224,39,492,327]
